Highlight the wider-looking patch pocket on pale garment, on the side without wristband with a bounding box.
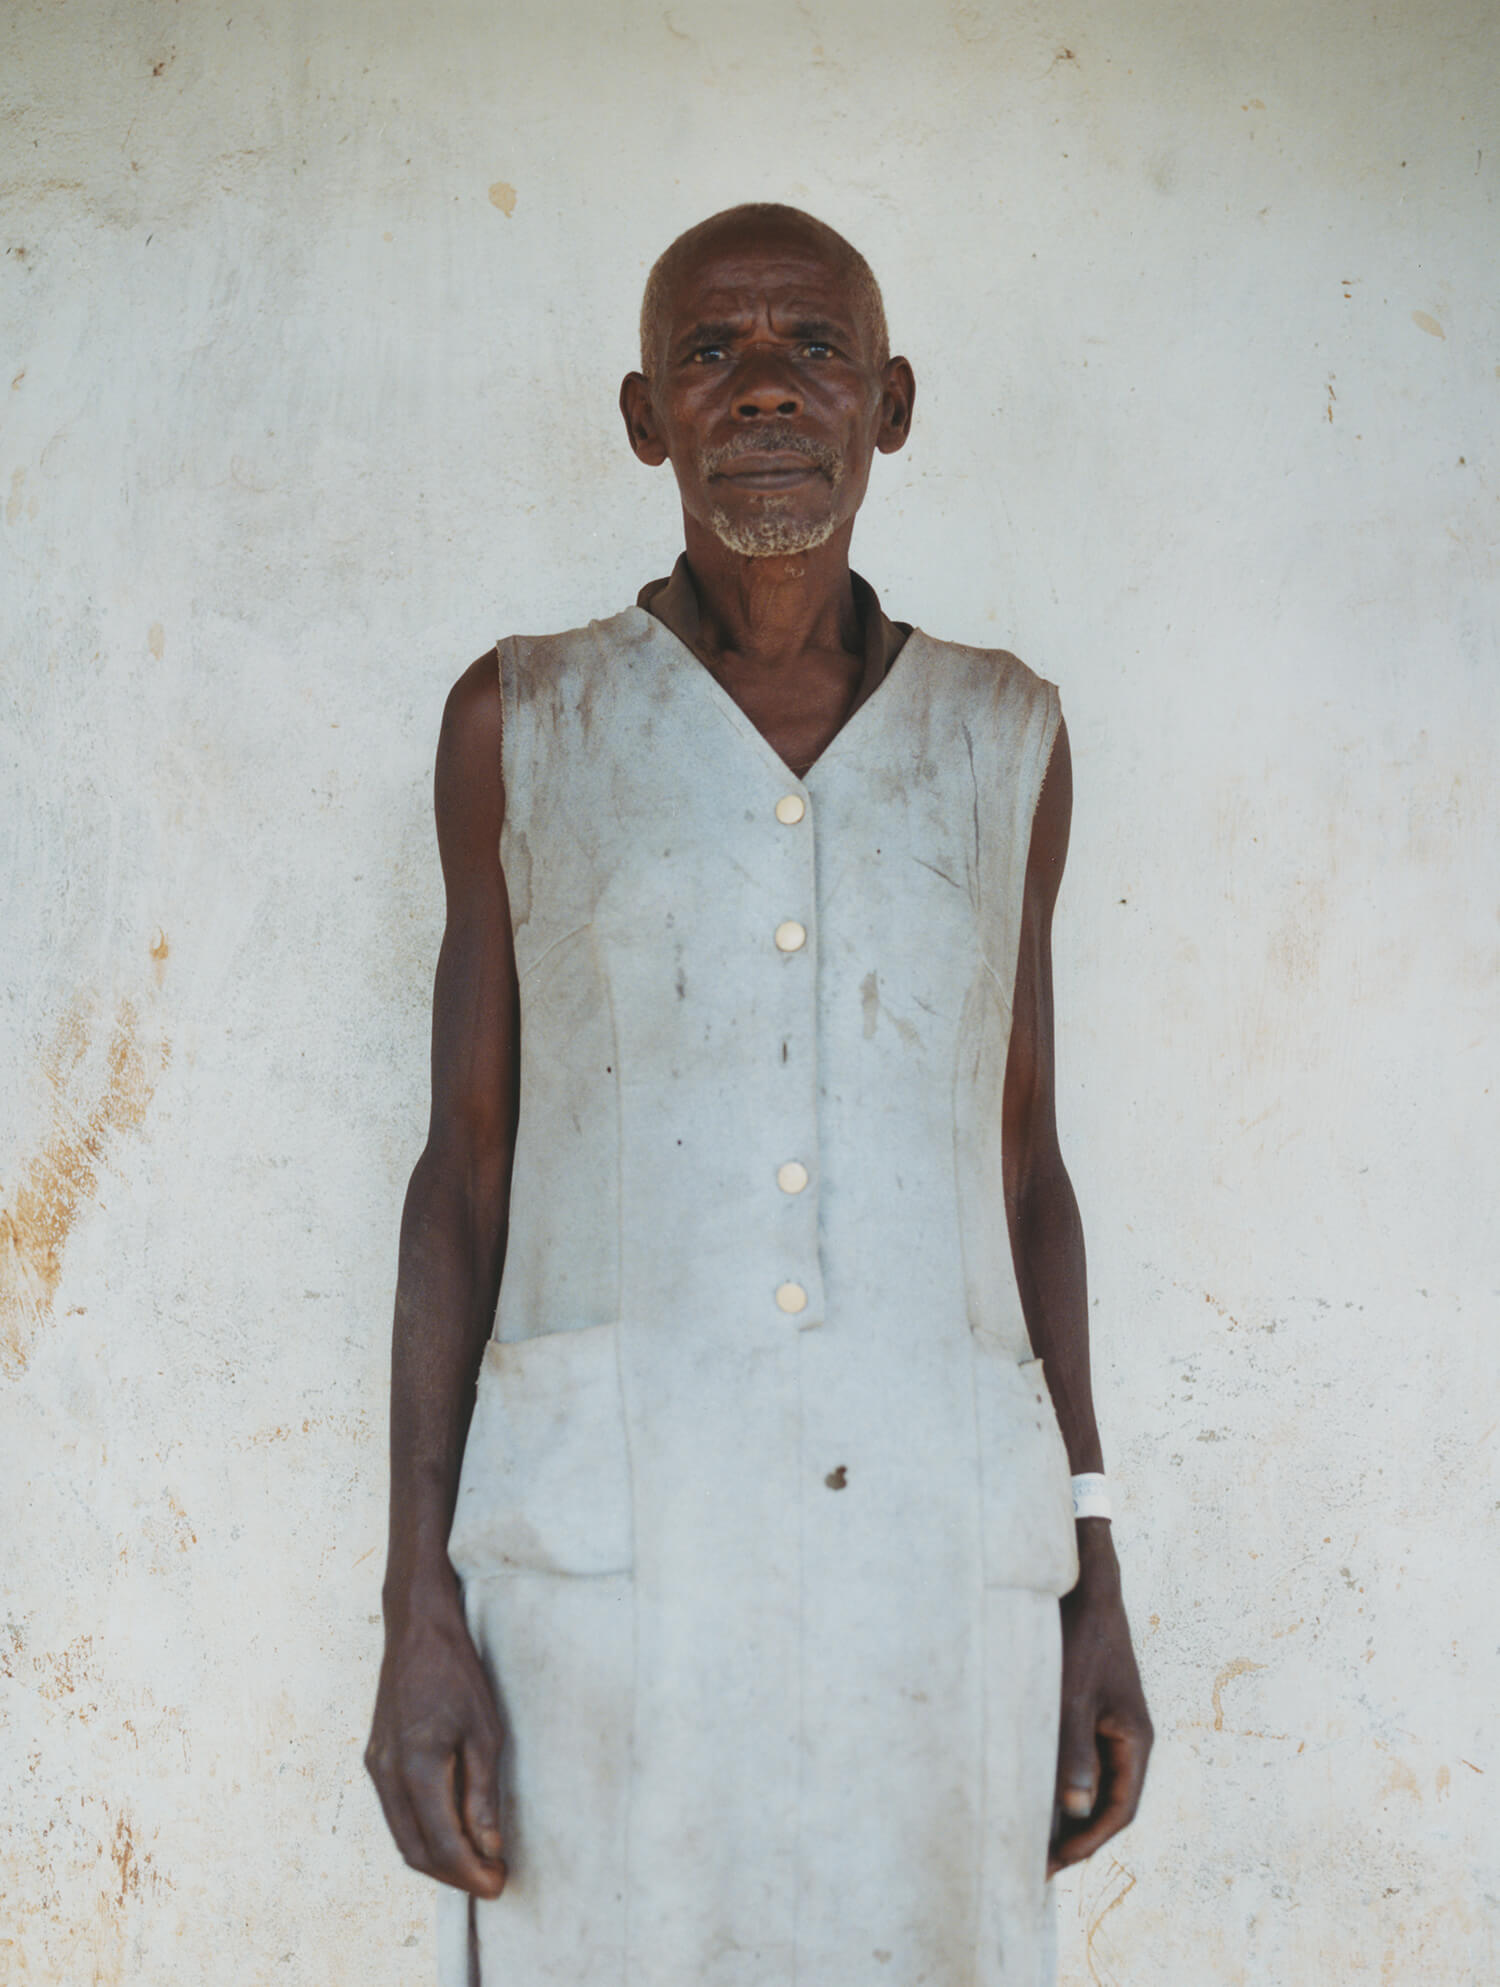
[447,1323,632,1580]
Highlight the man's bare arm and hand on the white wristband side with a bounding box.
[1003,727,1152,1870]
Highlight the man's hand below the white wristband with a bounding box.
[1047,1518,1152,1876]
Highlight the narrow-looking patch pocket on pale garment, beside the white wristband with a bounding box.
[974,1333,1079,1594]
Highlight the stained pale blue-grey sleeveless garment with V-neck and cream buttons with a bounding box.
[439,606,1077,1987]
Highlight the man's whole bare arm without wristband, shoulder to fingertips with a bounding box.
[366,652,519,1898]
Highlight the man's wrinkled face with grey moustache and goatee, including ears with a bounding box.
[622,223,910,558]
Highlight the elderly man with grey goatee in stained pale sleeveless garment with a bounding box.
[368,207,1150,1987]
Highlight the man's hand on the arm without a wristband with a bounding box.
[366,1572,505,1898]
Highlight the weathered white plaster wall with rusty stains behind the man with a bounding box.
[0,0,1500,1987]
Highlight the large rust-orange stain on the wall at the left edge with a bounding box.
[0,999,165,1377]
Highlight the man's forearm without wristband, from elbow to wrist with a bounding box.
[385,1148,505,1611]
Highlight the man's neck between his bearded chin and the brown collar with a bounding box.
[675,519,862,670]
